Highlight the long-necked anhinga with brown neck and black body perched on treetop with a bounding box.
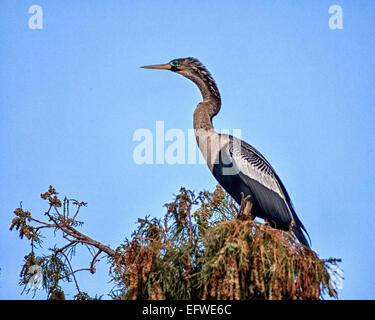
[142,58,309,246]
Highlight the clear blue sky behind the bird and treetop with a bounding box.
[0,0,375,299]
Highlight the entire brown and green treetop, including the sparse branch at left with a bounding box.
[10,186,339,300]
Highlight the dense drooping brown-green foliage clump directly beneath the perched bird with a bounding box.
[111,186,338,299]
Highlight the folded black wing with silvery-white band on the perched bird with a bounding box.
[214,137,309,246]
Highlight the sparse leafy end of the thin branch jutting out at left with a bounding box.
[10,186,97,300]
